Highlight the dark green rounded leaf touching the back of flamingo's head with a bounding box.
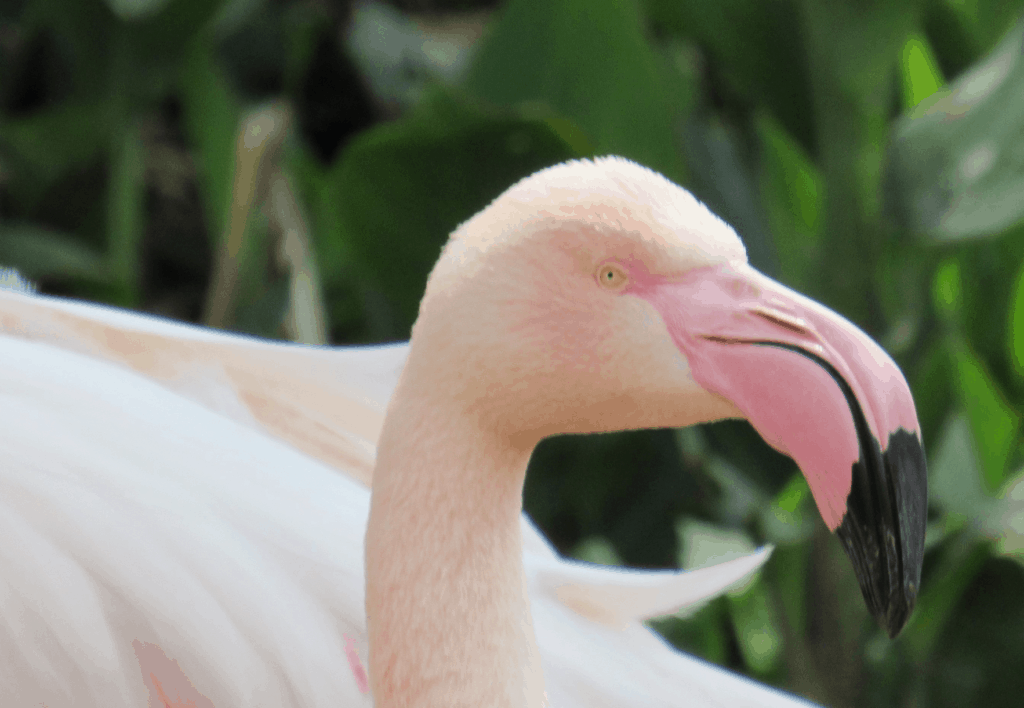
[329,88,575,337]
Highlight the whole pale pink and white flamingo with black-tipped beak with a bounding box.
[0,158,927,708]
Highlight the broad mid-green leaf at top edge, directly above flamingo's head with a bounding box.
[465,0,685,181]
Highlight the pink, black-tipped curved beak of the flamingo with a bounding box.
[633,264,928,637]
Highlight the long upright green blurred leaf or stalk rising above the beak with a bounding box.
[800,0,916,321]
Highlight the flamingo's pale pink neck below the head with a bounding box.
[366,391,545,708]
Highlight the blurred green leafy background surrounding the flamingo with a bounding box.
[0,0,1024,708]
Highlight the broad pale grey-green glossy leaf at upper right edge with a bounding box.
[886,20,1024,240]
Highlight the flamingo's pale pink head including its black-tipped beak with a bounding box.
[407,158,927,636]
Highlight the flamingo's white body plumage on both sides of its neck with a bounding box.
[0,284,806,708]
